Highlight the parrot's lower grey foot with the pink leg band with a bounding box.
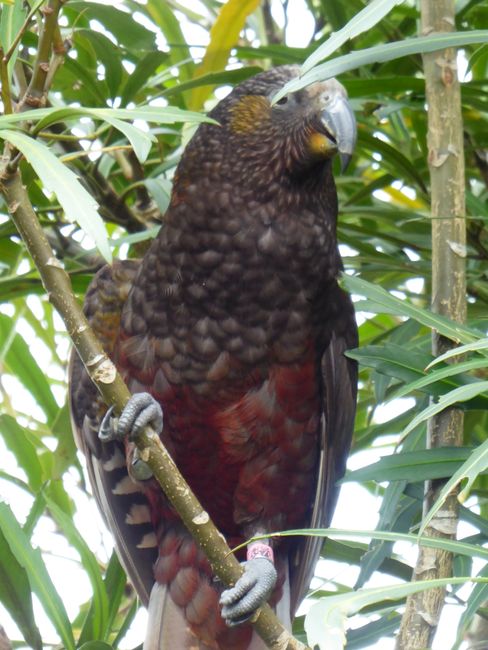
[220,544,277,627]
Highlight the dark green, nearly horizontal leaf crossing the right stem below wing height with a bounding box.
[341,447,473,483]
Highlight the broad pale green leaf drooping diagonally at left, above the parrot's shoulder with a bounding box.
[0,129,112,263]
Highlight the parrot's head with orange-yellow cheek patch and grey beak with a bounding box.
[181,65,356,183]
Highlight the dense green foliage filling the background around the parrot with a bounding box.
[0,0,488,648]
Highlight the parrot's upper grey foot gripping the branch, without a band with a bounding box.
[98,393,163,481]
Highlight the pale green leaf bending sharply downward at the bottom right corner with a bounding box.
[305,576,488,650]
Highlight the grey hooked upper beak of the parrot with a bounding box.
[320,86,357,171]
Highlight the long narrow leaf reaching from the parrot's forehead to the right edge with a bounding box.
[273,29,488,103]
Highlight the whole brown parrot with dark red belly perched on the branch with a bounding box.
[71,66,357,650]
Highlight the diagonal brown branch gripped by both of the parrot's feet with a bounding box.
[0,160,306,650]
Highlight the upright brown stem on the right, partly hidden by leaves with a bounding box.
[396,0,466,650]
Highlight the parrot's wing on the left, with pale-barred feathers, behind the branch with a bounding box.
[69,260,157,605]
